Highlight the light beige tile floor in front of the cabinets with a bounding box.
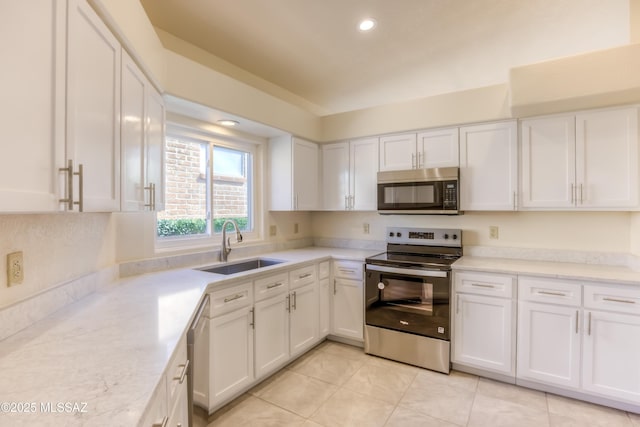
[204,341,640,427]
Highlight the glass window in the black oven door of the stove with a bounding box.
[380,276,433,315]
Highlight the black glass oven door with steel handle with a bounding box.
[365,264,451,341]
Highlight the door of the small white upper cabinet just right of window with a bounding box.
[293,138,319,211]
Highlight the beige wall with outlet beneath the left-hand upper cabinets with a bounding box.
[0,213,115,308]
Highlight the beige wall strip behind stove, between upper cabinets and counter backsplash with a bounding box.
[312,212,640,253]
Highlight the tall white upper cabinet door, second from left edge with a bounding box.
[67,0,121,212]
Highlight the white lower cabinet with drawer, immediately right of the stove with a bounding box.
[452,272,516,377]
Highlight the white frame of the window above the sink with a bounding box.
[153,123,266,253]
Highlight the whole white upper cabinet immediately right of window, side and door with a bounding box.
[269,136,319,211]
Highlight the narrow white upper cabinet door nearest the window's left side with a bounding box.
[144,83,165,211]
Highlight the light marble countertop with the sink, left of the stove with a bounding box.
[0,247,379,427]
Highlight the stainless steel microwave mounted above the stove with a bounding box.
[378,167,460,215]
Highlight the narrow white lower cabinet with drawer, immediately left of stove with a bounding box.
[332,261,364,341]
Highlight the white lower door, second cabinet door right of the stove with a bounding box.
[517,301,582,388]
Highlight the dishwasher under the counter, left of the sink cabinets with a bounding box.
[187,295,209,427]
